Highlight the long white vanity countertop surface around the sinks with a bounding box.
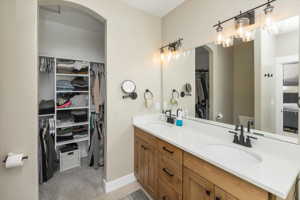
[133,115,300,199]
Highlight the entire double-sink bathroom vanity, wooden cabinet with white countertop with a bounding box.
[133,117,300,200]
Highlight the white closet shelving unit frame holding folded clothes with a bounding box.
[54,58,91,149]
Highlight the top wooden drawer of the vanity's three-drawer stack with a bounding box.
[158,140,182,164]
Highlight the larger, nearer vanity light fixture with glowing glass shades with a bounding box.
[213,0,276,47]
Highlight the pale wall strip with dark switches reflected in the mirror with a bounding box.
[254,30,276,132]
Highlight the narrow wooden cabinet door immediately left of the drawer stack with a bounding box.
[143,143,158,198]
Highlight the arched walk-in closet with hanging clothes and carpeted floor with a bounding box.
[38,4,106,200]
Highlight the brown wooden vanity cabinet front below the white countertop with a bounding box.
[134,128,277,200]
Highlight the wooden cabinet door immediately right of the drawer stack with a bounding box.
[183,168,214,200]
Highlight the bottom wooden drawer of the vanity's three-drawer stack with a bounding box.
[158,181,182,200]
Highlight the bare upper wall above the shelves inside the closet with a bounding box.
[39,19,105,63]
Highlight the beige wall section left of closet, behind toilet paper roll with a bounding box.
[0,0,38,200]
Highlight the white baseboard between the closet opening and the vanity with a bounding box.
[103,173,136,193]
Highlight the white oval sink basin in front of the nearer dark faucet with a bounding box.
[203,144,262,168]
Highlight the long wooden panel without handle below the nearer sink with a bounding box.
[183,153,269,200]
